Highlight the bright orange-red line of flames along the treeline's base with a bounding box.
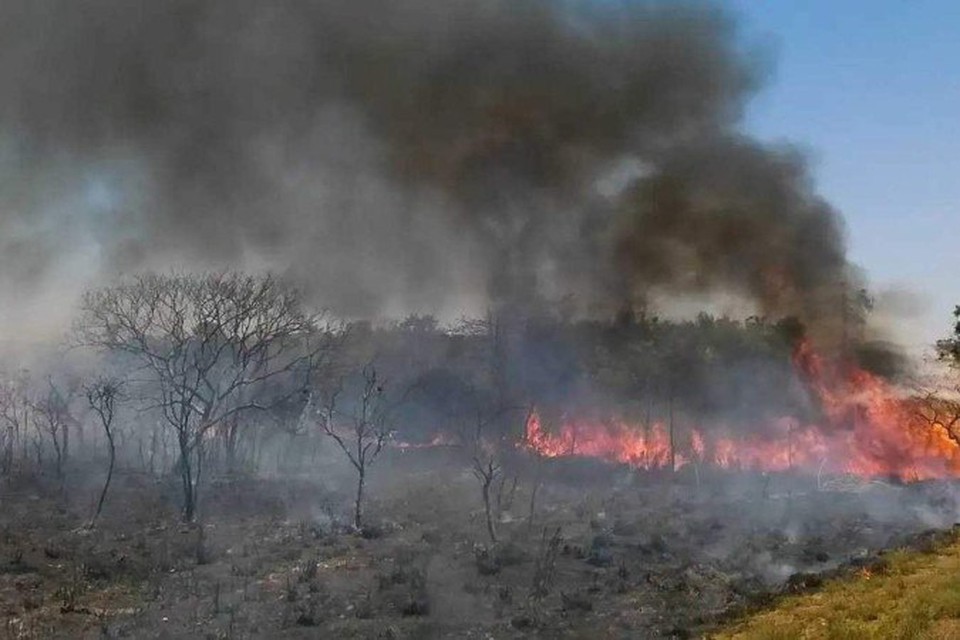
[522,343,960,481]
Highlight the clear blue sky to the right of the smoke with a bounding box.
[724,0,960,347]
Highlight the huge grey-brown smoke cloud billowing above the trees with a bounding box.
[0,0,846,330]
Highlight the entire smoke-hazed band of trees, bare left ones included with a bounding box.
[0,273,856,521]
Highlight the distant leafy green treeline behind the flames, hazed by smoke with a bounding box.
[368,314,808,439]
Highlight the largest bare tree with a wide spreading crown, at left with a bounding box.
[76,272,335,520]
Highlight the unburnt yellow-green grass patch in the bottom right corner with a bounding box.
[711,540,960,640]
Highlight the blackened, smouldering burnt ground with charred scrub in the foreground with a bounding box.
[0,448,958,639]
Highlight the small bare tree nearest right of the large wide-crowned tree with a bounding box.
[319,364,391,531]
